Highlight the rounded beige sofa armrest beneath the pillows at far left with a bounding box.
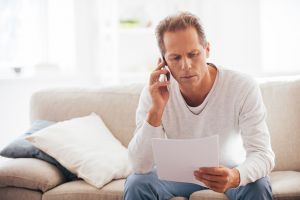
[0,158,65,192]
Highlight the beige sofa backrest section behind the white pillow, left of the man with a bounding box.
[30,84,143,147]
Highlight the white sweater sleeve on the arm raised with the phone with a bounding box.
[128,86,165,174]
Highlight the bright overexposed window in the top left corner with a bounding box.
[0,0,75,76]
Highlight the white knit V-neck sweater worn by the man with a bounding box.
[128,67,274,185]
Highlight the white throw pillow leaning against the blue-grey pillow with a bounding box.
[26,113,131,188]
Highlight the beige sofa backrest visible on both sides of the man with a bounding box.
[30,79,300,171]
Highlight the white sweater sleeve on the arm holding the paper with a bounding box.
[236,80,275,186]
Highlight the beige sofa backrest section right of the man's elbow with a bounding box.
[260,78,300,171]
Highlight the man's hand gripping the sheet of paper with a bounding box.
[194,166,240,193]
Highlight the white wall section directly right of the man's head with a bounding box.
[193,0,261,73]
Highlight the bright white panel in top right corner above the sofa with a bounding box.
[261,0,300,74]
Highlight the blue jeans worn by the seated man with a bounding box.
[124,171,272,200]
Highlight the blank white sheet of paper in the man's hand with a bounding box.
[152,135,219,186]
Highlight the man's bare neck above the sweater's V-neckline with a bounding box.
[180,65,217,107]
